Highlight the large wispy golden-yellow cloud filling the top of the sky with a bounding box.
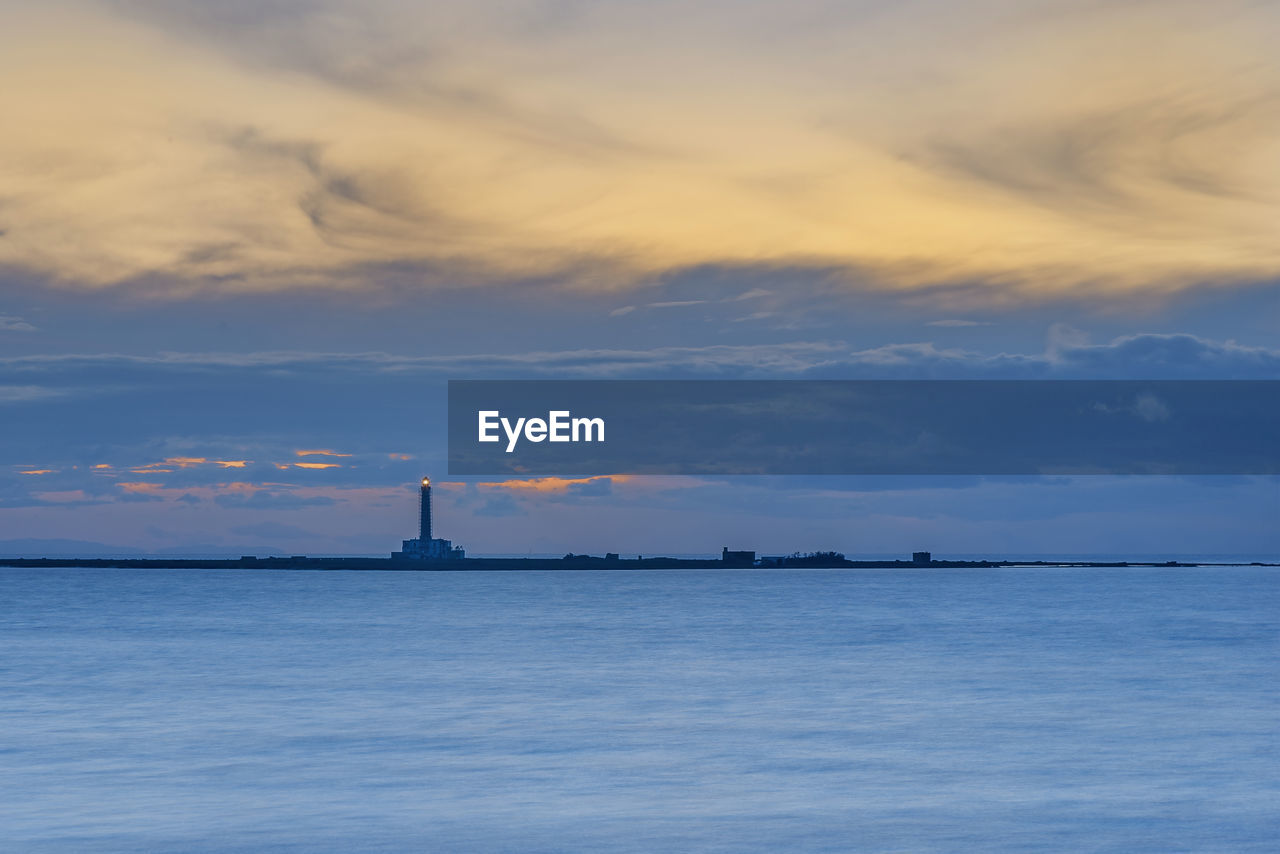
[0,0,1280,300]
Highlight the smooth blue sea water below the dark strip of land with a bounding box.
[0,567,1280,853]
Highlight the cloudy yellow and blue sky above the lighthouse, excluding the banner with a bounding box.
[0,0,1280,554]
